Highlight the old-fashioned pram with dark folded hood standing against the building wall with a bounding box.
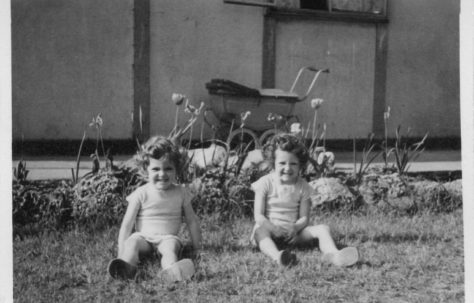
[206,66,329,148]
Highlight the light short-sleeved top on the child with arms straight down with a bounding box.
[127,183,192,236]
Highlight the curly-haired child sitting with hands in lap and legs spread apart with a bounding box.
[251,134,359,266]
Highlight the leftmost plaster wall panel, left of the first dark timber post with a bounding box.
[11,0,133,140]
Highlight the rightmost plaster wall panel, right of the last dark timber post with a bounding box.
[387,0,460,137]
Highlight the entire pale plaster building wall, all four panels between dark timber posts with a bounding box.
[12,0,460,139]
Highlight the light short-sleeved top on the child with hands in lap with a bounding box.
[251,172,313,223]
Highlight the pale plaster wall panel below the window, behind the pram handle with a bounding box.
[276,20,375,139]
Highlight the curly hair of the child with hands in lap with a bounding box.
[263,133,309,169]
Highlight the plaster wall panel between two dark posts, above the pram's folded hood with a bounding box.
[150,0,264,136]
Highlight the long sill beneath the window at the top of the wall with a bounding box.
[266,8,388,23]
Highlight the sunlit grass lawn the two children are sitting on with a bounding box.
[13,209,464,302]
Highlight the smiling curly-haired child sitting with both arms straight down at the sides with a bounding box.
[108,136,201,282]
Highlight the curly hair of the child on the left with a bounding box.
[135,136,185,172]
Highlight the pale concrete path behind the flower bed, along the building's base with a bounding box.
[12,150,462,180]
